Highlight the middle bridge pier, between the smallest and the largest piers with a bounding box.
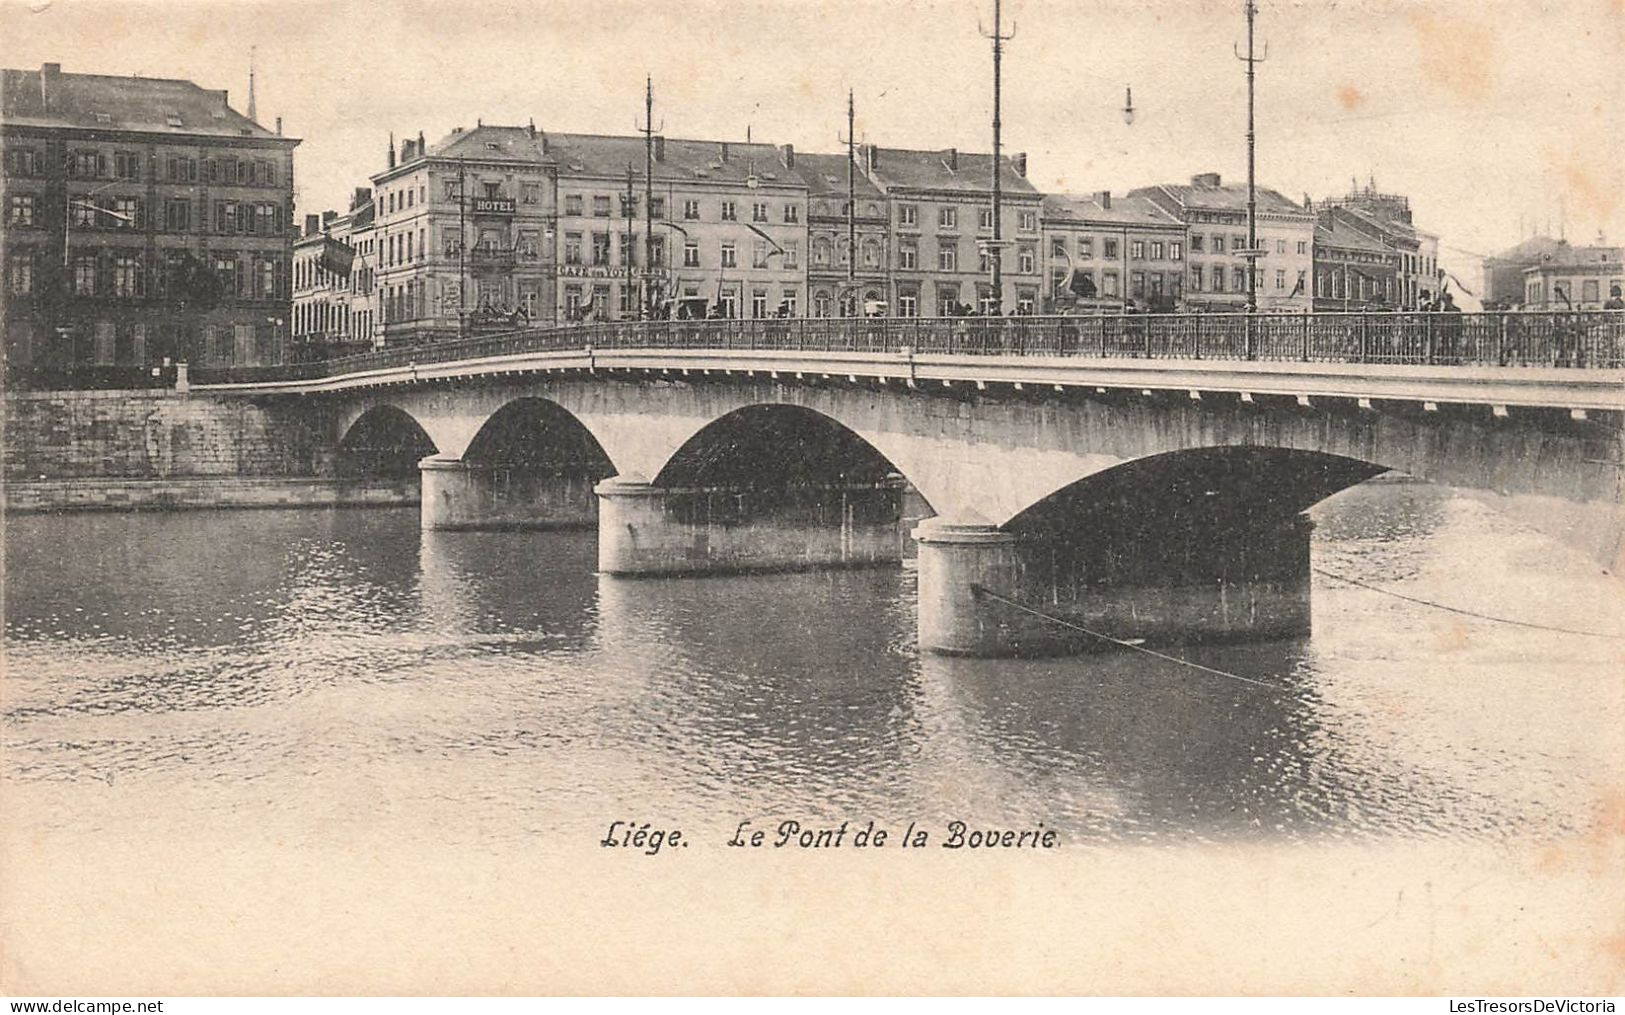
[595,476,904,575]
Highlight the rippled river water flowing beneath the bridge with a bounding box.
[0,484,1625,849]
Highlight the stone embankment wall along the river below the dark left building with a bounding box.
[0,391,418,512]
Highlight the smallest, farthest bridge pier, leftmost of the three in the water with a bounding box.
[418,455,598,529]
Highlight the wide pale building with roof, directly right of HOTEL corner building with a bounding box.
[546,133,808,320]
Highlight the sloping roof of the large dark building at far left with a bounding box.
[0,63,286,145]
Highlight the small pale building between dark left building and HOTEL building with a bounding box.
[289,187,384,361]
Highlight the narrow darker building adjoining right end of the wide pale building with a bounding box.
[780,145,890,317]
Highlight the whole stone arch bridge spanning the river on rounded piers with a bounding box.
[206,315,1625,654]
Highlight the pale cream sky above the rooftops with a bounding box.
[0,0,1625,287]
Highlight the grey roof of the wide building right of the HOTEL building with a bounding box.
[538,133,803,187]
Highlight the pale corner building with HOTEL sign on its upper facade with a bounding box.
[369,123,556,346]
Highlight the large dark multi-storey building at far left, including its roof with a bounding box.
[0,63,299,385]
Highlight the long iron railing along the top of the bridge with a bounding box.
[192,310,1625,383]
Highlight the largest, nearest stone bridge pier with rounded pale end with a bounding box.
[913,515,1313,656]
